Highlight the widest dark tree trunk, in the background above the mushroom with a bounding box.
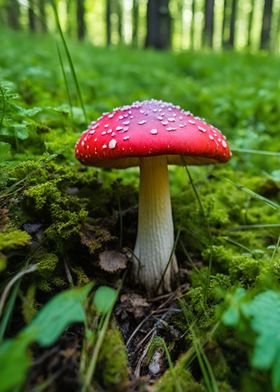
[145,0,171,49]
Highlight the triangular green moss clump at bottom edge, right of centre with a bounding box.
[153,353,206,392]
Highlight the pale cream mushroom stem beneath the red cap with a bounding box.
[133,156,177,294]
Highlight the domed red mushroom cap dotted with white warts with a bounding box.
[76,99,231,168]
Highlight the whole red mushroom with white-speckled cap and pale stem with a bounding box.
[76,100,231,295]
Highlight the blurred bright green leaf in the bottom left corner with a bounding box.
[0,333,34,392]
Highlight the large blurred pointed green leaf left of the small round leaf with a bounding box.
[26,283,93,346]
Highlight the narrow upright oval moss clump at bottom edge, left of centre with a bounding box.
[97,326,128,390]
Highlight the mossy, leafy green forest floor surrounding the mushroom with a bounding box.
[0,26,280,392]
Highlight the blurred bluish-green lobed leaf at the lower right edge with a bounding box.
[241,290,280,371]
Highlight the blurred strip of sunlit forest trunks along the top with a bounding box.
[0,0,280,52]
